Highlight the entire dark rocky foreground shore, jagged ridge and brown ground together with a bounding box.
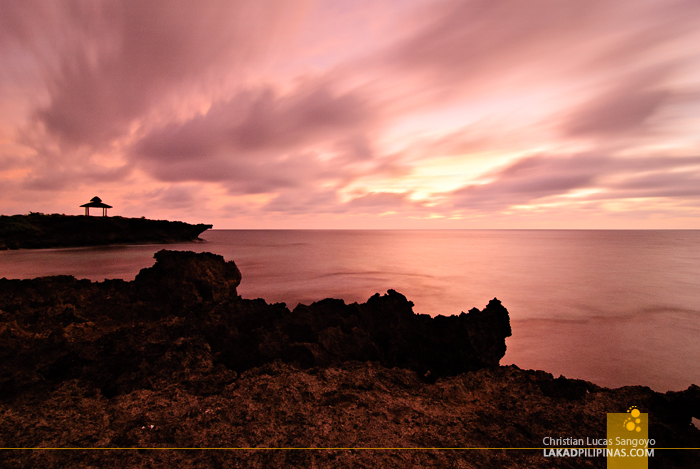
[0,251,700,468]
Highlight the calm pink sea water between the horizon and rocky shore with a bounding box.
[0,230,700,391]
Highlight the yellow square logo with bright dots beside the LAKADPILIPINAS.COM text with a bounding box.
[607,406,655,469]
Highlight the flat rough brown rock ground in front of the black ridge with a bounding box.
[0,360,700,468]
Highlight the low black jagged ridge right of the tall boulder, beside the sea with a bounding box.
[216,290,511,381]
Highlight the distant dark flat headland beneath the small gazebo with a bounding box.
[0,213,212,249]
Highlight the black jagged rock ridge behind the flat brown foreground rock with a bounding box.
[0,250,510,397]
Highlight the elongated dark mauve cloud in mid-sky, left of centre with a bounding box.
[134,84,370,161]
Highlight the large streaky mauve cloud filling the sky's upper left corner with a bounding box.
[2,0,304,146]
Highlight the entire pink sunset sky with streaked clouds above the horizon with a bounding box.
[0,0,700,229]
